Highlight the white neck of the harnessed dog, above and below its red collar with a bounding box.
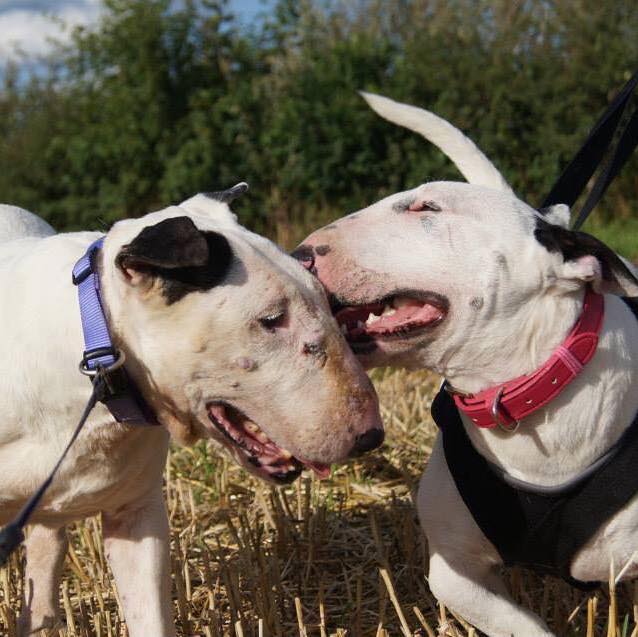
[448,295,638,486]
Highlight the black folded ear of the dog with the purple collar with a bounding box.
[116,217,233,305]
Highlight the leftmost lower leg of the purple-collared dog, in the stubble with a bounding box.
[18,524,68,637]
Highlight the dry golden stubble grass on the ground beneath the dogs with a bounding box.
[0,370,638,637]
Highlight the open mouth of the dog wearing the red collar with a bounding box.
[333,292,449,351]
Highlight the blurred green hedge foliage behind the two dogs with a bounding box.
[0,0,638,248]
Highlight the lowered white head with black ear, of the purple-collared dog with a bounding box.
[99,186,383,482]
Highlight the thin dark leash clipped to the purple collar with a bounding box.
[0,373,105,568]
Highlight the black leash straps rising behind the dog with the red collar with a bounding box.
[541,71,638,230]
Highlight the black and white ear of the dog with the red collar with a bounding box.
[534,219,638,297]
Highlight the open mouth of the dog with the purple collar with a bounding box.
[207,403,330,484]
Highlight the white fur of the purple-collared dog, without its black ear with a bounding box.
[0,196,380,637]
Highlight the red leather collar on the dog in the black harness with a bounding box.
[448,288,605,431]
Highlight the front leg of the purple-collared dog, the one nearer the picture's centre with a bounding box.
[102,486,175,637]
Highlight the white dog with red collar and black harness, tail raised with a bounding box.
[296,95,638,637]
